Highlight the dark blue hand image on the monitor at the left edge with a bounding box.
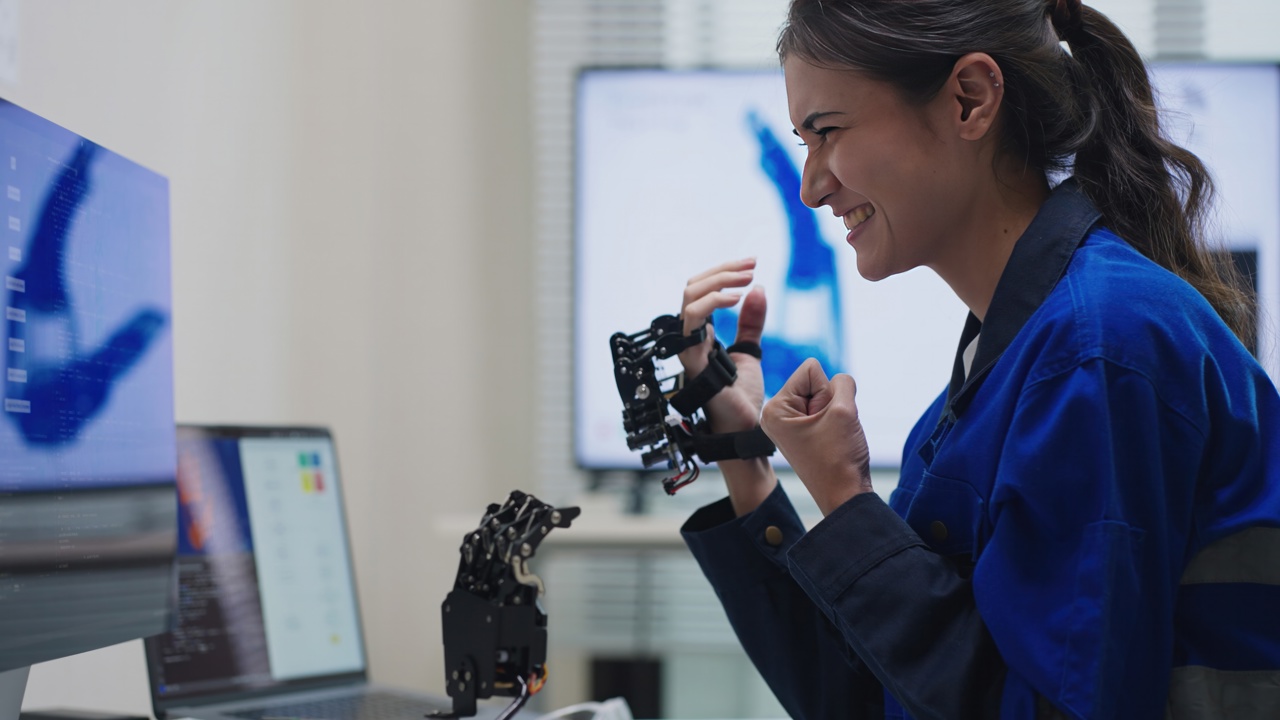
[5,142,168,447]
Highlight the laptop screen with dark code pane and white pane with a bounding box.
[146,425,365,705]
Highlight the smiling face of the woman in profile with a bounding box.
[783,58,975,281]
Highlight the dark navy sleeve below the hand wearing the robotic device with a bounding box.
[681,484,884,720]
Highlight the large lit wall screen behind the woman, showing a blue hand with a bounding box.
[573,64,1280,469]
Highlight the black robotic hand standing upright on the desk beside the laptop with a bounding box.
[436,491,581,720]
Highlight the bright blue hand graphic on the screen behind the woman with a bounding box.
[712,110,845,395]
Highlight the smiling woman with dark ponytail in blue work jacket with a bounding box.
[665,0,1280,720]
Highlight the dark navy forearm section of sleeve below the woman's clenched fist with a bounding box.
[790,493,1003,720]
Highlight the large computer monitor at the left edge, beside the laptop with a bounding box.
[0,100,178,720]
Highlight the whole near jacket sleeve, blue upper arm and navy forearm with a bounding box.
[788,360,1201,720]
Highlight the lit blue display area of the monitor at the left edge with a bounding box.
[0,101,175,493]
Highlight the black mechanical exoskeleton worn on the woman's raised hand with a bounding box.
[609,315,776,495]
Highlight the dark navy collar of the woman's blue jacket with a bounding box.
[945,178,1102,420]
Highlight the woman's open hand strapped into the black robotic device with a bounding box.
[680,258,765,433]
